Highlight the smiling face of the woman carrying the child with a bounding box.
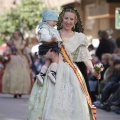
[62,12,76,30]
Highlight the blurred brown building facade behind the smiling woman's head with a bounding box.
[45,0,120,39]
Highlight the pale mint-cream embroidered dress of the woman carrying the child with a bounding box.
[27,32,93,120]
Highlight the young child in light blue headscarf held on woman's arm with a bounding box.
[36,10,62,85]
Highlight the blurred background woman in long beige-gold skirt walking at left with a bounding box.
[2,30,31,98]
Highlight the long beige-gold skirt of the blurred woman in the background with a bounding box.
[2,55,31,94]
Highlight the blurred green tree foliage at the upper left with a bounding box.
[0,0,46,35]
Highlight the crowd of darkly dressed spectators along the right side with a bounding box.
[88,31,120,114]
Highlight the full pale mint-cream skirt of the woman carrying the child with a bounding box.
[27,61,92,120]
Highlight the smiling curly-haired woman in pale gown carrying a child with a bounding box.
[28,8,99,120]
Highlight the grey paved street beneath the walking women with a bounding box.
[0,94,120,120]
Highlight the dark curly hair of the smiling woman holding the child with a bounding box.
[57,6,84,32]
